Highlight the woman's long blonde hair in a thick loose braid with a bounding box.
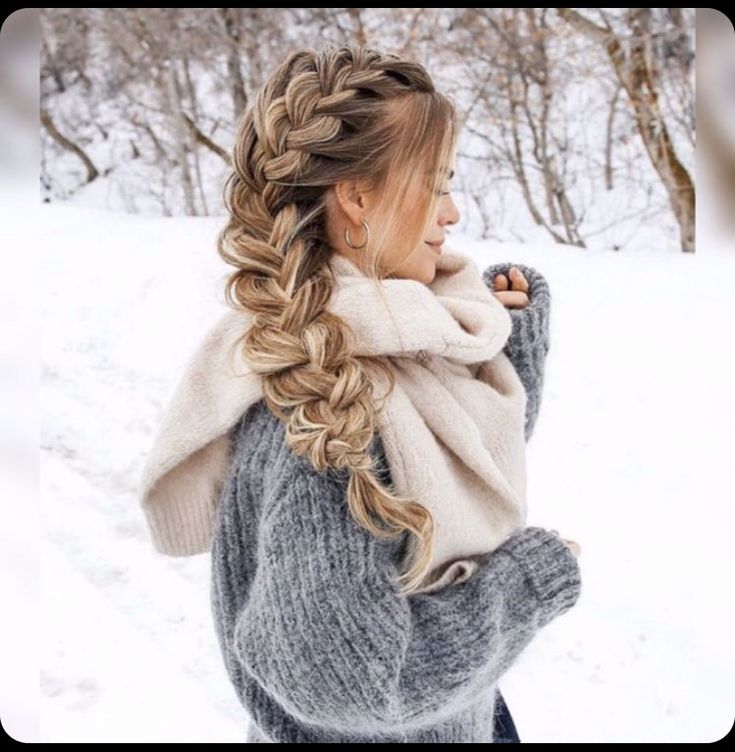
[217,43,459,594]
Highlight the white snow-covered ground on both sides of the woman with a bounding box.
[38,205,735,742]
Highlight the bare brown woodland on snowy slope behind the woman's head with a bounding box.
[41,8,694,253]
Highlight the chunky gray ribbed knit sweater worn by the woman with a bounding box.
[211,264,581,743]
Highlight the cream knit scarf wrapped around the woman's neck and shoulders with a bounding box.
[139,246,526,592]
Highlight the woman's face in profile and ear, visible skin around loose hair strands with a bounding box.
[328,170,460,285]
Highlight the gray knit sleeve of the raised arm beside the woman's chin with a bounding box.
[482,261,551,441]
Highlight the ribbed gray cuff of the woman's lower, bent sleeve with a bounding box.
[496,527,582,623]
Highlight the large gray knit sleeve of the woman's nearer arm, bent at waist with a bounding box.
[233,438,581,734]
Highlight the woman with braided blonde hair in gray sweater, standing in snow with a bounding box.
[160,39,581,743]
